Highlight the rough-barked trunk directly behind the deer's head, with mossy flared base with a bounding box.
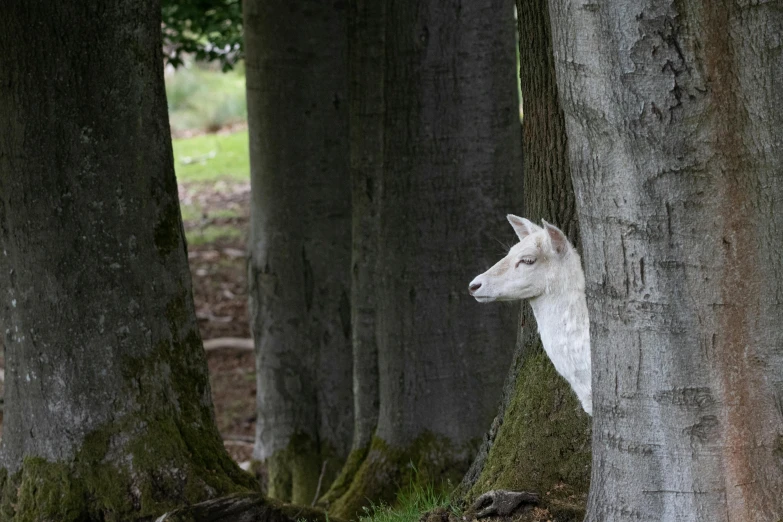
[460,0,590,520]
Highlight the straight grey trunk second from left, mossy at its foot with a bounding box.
[244,0,353,505]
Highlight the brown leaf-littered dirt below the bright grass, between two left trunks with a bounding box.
[180,181,256,462]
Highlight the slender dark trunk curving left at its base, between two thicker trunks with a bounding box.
[320,0,386,507]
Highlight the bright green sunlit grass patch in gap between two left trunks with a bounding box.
[172,130,250,183]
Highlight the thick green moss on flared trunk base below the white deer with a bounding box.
[466,349,591,509]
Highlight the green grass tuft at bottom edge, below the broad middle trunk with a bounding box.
[359,481,461,522]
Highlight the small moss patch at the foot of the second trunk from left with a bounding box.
[264,433,342,506]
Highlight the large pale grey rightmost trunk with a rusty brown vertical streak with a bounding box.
[550,0,783,522]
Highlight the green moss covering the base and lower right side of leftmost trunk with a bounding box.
[0,293,257,522]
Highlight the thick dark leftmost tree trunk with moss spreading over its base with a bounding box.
[0,1,254,521]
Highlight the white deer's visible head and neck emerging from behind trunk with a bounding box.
[469,215,593,415]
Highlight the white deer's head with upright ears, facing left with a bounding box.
[469,214,584,303]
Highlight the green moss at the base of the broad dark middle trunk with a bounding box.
[329,433,477,519]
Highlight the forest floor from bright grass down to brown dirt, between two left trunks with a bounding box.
[174,132,256,462]
